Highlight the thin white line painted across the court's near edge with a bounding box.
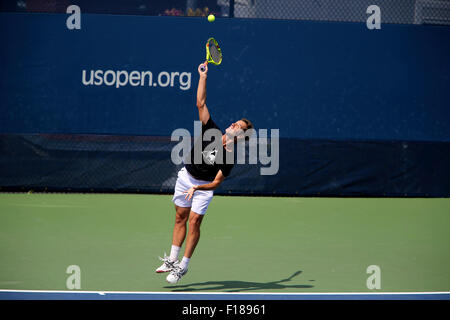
[0,289,450,296]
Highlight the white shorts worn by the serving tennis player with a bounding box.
[172,167,214,215]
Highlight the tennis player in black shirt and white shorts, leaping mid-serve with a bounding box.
[156,63,253,284]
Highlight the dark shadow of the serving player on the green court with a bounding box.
[164,270,314,292]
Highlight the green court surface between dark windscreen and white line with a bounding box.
[0,193,450,293]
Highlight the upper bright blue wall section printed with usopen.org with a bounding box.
[0,13,450,141]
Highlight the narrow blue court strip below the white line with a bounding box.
[0,290,450,300]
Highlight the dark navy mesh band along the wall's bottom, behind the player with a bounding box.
[0,134,450,197]
